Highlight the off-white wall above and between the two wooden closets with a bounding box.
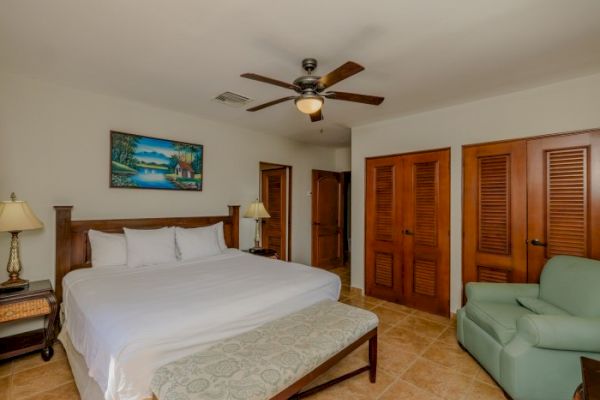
[352,74,600,311]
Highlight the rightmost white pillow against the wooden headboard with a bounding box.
[175,225,222,261]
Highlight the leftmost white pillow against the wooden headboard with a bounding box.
[88,229,127,267]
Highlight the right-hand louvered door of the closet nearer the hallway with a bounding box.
[403,150,450,315]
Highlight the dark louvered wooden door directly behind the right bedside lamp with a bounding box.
[261,168,288,260]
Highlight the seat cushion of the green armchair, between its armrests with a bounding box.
[465,300,531,345]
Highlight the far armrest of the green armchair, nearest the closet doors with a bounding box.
[466,282,540,303]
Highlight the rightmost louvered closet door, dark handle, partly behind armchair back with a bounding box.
[527,131,600,282]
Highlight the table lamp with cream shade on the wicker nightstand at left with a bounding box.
[0,193,44,288]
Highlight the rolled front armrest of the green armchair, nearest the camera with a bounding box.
[517,314,600,353]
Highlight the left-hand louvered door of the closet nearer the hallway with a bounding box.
[365,157,404,302]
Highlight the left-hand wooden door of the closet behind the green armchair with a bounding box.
[463,140,527,283]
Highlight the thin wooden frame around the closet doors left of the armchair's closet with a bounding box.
[363,147,452,316]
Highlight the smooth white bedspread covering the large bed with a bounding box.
[63,250,340,400]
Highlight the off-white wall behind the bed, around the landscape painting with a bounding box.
[0,74,336,288]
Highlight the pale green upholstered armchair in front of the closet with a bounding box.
[457,256,600,400]
